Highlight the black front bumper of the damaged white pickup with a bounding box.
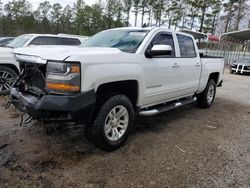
[10,88,96,122]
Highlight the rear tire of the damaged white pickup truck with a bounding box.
[197,79,216,108]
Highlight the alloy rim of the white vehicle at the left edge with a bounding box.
[0,70,15,92]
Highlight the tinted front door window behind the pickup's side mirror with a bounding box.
[150,33,175,57]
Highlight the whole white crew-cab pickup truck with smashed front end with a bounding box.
[9,28,224,151]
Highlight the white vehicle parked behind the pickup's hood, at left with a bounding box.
[0,34,88,95]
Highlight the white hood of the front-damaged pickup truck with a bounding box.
[14,46,121,61]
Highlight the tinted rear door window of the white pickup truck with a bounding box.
[177,34,196,57]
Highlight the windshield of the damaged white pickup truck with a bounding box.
[82,30,149,53]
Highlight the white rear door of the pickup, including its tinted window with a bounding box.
[176,34,201,96]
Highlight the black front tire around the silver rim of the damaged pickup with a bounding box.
[86,95,135,151]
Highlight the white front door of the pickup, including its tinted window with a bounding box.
[143,32,180,105]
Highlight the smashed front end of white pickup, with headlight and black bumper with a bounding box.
[7,55,95,123]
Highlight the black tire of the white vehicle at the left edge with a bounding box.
[0,66,18,95]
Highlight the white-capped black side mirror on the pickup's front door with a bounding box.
[146,44,173,58]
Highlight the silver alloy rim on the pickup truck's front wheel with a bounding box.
[104,106,129,141]
